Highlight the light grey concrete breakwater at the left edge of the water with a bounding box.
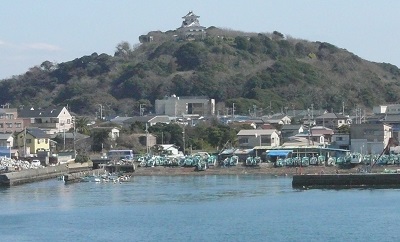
[0,165,68,186]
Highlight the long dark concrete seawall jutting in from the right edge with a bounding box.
[292,173,400,188]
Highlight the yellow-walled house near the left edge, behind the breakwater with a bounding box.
[16,128,50,156]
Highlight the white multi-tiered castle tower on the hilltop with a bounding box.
[177,11,206,39]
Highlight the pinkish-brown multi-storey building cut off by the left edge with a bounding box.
[0,108,24,133]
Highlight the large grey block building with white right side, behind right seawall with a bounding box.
[350,124,392,154]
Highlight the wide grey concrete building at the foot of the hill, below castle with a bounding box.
[155,95,215,117]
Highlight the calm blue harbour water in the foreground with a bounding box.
[0,175,400,241]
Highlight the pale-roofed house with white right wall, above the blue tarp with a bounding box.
[237,129,280,149]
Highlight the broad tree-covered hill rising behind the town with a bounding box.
[0,27,400,115]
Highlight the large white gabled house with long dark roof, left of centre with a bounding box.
[18,107,73,134]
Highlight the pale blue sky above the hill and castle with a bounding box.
[0,0,400,80]
